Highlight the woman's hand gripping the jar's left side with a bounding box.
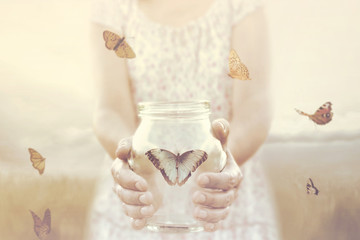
[111,138,155,229]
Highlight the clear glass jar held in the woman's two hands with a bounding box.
[129,101,226,232]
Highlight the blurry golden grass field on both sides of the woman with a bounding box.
[0,141,360,240]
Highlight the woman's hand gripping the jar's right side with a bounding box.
[193,119,242,231]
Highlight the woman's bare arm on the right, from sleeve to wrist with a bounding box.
[228,8,272,166]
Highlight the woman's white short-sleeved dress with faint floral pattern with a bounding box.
[88,0,278,240]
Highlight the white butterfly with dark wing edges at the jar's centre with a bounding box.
[145,148,208,186]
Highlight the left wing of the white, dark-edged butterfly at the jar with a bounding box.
[145,148,177,185]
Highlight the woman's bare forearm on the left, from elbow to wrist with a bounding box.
[93,109,135,159]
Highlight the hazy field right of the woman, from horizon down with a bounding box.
[264,143,360,240]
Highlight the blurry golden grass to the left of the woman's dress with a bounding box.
[0,175,96,240]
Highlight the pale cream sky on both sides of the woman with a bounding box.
[0,0,360,170]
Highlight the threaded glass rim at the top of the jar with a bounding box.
[138,100,210,118]
